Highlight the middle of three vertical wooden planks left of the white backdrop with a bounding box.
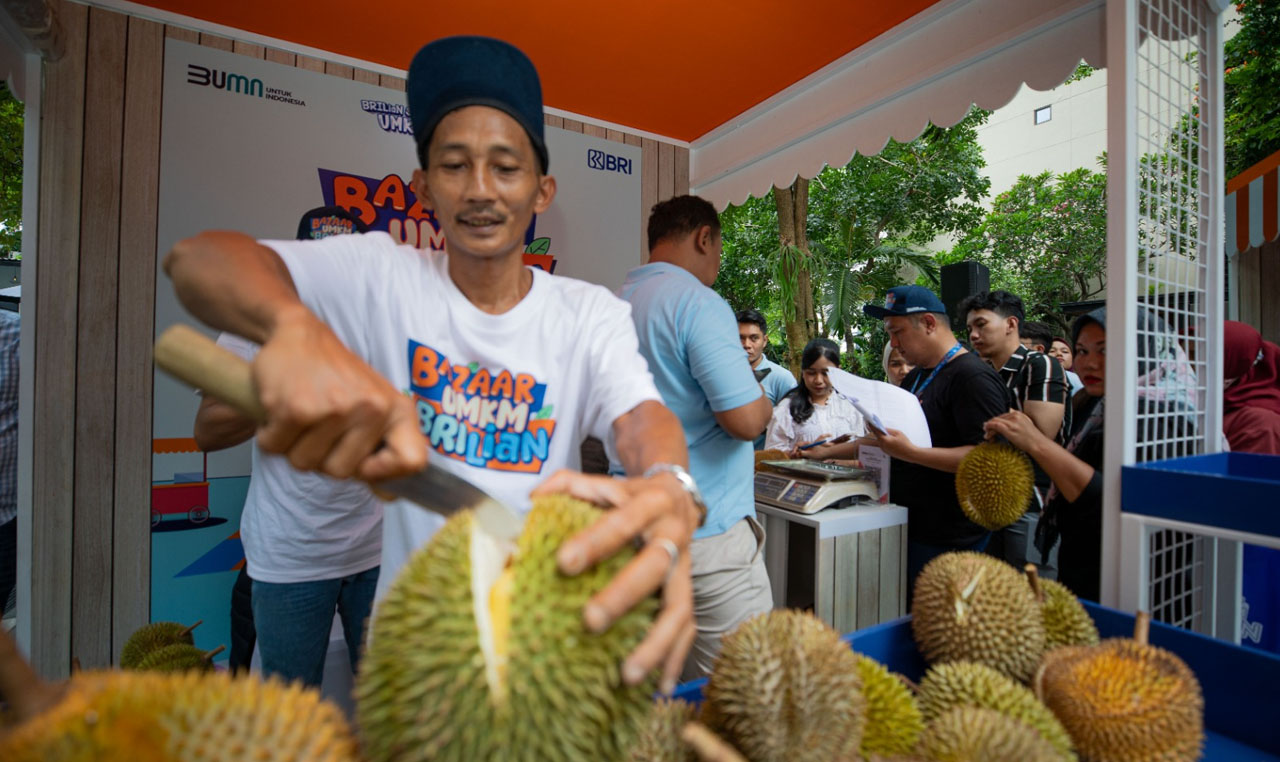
[72,8,128,669]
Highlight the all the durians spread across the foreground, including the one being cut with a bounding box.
[0,497,1203,762]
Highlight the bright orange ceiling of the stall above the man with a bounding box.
[135,0,938,141]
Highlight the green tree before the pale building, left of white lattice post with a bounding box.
[940,168,1107,328]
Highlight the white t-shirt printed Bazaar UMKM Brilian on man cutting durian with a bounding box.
[264,232,662,596]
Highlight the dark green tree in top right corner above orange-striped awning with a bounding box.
[1222,0,1280,178]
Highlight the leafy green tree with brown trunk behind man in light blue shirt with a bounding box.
[714,109,989,375]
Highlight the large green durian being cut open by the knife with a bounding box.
[356,496,657,762]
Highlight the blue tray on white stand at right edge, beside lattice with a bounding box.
[1120,452,1280,537]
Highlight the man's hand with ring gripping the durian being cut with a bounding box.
[532,471,701,694]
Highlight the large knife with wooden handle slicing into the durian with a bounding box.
[155,325,524,542]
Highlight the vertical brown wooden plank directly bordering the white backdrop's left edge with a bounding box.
[111,18,164,657]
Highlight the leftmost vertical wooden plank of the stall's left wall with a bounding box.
[29,1,88,679]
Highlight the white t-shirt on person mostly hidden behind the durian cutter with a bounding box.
[218,333,383,583]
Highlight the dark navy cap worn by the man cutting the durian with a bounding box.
[404,36,548,172]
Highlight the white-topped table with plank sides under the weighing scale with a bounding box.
[755,502,906,633]
